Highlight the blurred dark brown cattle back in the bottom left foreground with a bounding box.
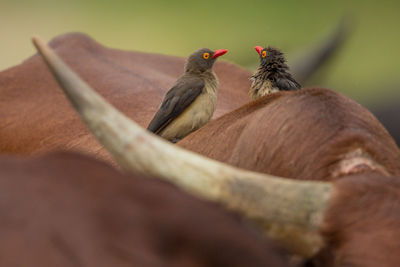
[0,153,288,267]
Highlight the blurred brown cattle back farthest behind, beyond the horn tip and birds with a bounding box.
[0,31,251,160]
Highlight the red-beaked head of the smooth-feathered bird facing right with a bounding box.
[185,48,228,72]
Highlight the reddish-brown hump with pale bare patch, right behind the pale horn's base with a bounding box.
[178,88,400,180]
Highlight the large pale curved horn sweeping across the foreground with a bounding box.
[33,37,333,256]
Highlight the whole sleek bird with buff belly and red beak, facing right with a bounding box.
[147,48,228,143]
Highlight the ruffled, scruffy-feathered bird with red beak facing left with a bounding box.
[249,46,301,99]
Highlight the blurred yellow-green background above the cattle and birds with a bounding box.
[0,0,400,105]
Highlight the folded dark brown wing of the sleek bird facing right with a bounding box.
[147,78,204,134]
